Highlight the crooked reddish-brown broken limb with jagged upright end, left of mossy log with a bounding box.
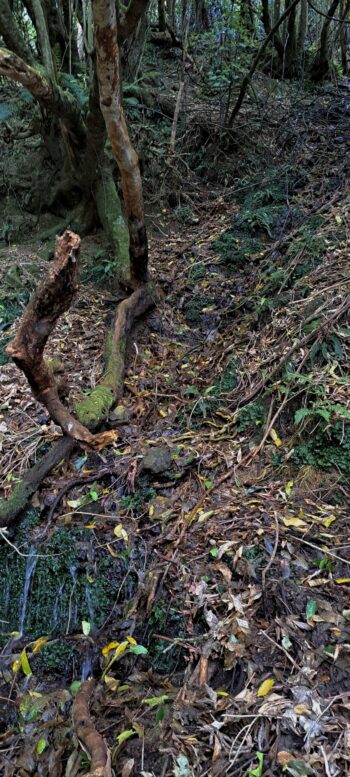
[6,231,114,449]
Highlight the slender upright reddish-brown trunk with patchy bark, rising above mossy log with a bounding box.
[93,0,148,288]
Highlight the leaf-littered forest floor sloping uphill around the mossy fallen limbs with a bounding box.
[0,68,350,777]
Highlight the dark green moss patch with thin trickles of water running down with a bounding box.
[0,525,143,674]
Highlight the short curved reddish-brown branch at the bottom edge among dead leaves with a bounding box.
[73,680,112,777]
